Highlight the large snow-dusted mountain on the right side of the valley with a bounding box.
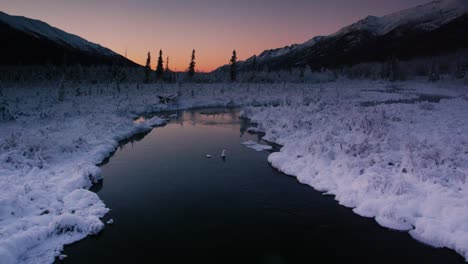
[221,0,468,70]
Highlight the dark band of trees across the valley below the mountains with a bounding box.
[0,50,468,83]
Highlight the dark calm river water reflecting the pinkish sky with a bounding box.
[57,109,464,264]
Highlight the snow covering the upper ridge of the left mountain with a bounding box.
[0,11,117,56]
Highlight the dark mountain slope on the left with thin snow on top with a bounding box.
[0,12,136,66]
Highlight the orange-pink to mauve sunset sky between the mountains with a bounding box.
[0,0,428,71]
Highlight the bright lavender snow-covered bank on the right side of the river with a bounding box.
[243,83,468,260]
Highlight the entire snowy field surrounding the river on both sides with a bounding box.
[0,81,468,264]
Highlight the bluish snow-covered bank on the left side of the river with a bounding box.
[0,83,296,264]
